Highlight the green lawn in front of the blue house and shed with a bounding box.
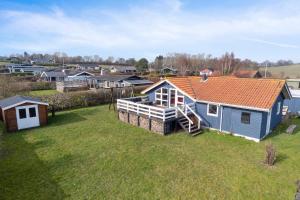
[0,105,300,200]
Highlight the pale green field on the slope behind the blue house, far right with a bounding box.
[260,64,300,78]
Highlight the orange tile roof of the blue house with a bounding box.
[167,76,285,109]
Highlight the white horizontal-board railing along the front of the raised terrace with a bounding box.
[117,99,176,121]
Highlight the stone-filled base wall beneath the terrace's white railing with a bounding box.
[118,110,174,135]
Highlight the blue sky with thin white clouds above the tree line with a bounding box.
[0,0,300,62]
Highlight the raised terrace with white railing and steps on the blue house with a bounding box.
[117,96,202,134]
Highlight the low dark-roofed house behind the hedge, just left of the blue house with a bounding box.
[88,75,153,88]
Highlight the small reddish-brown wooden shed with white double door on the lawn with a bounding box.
[0,96,48,132]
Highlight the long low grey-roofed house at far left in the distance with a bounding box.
[5,64,45,75]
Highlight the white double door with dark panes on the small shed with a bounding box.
[16,105,40,130]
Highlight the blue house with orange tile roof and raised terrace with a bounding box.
[117,77,291,141]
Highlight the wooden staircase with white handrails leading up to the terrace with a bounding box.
[177,104,202,136]
